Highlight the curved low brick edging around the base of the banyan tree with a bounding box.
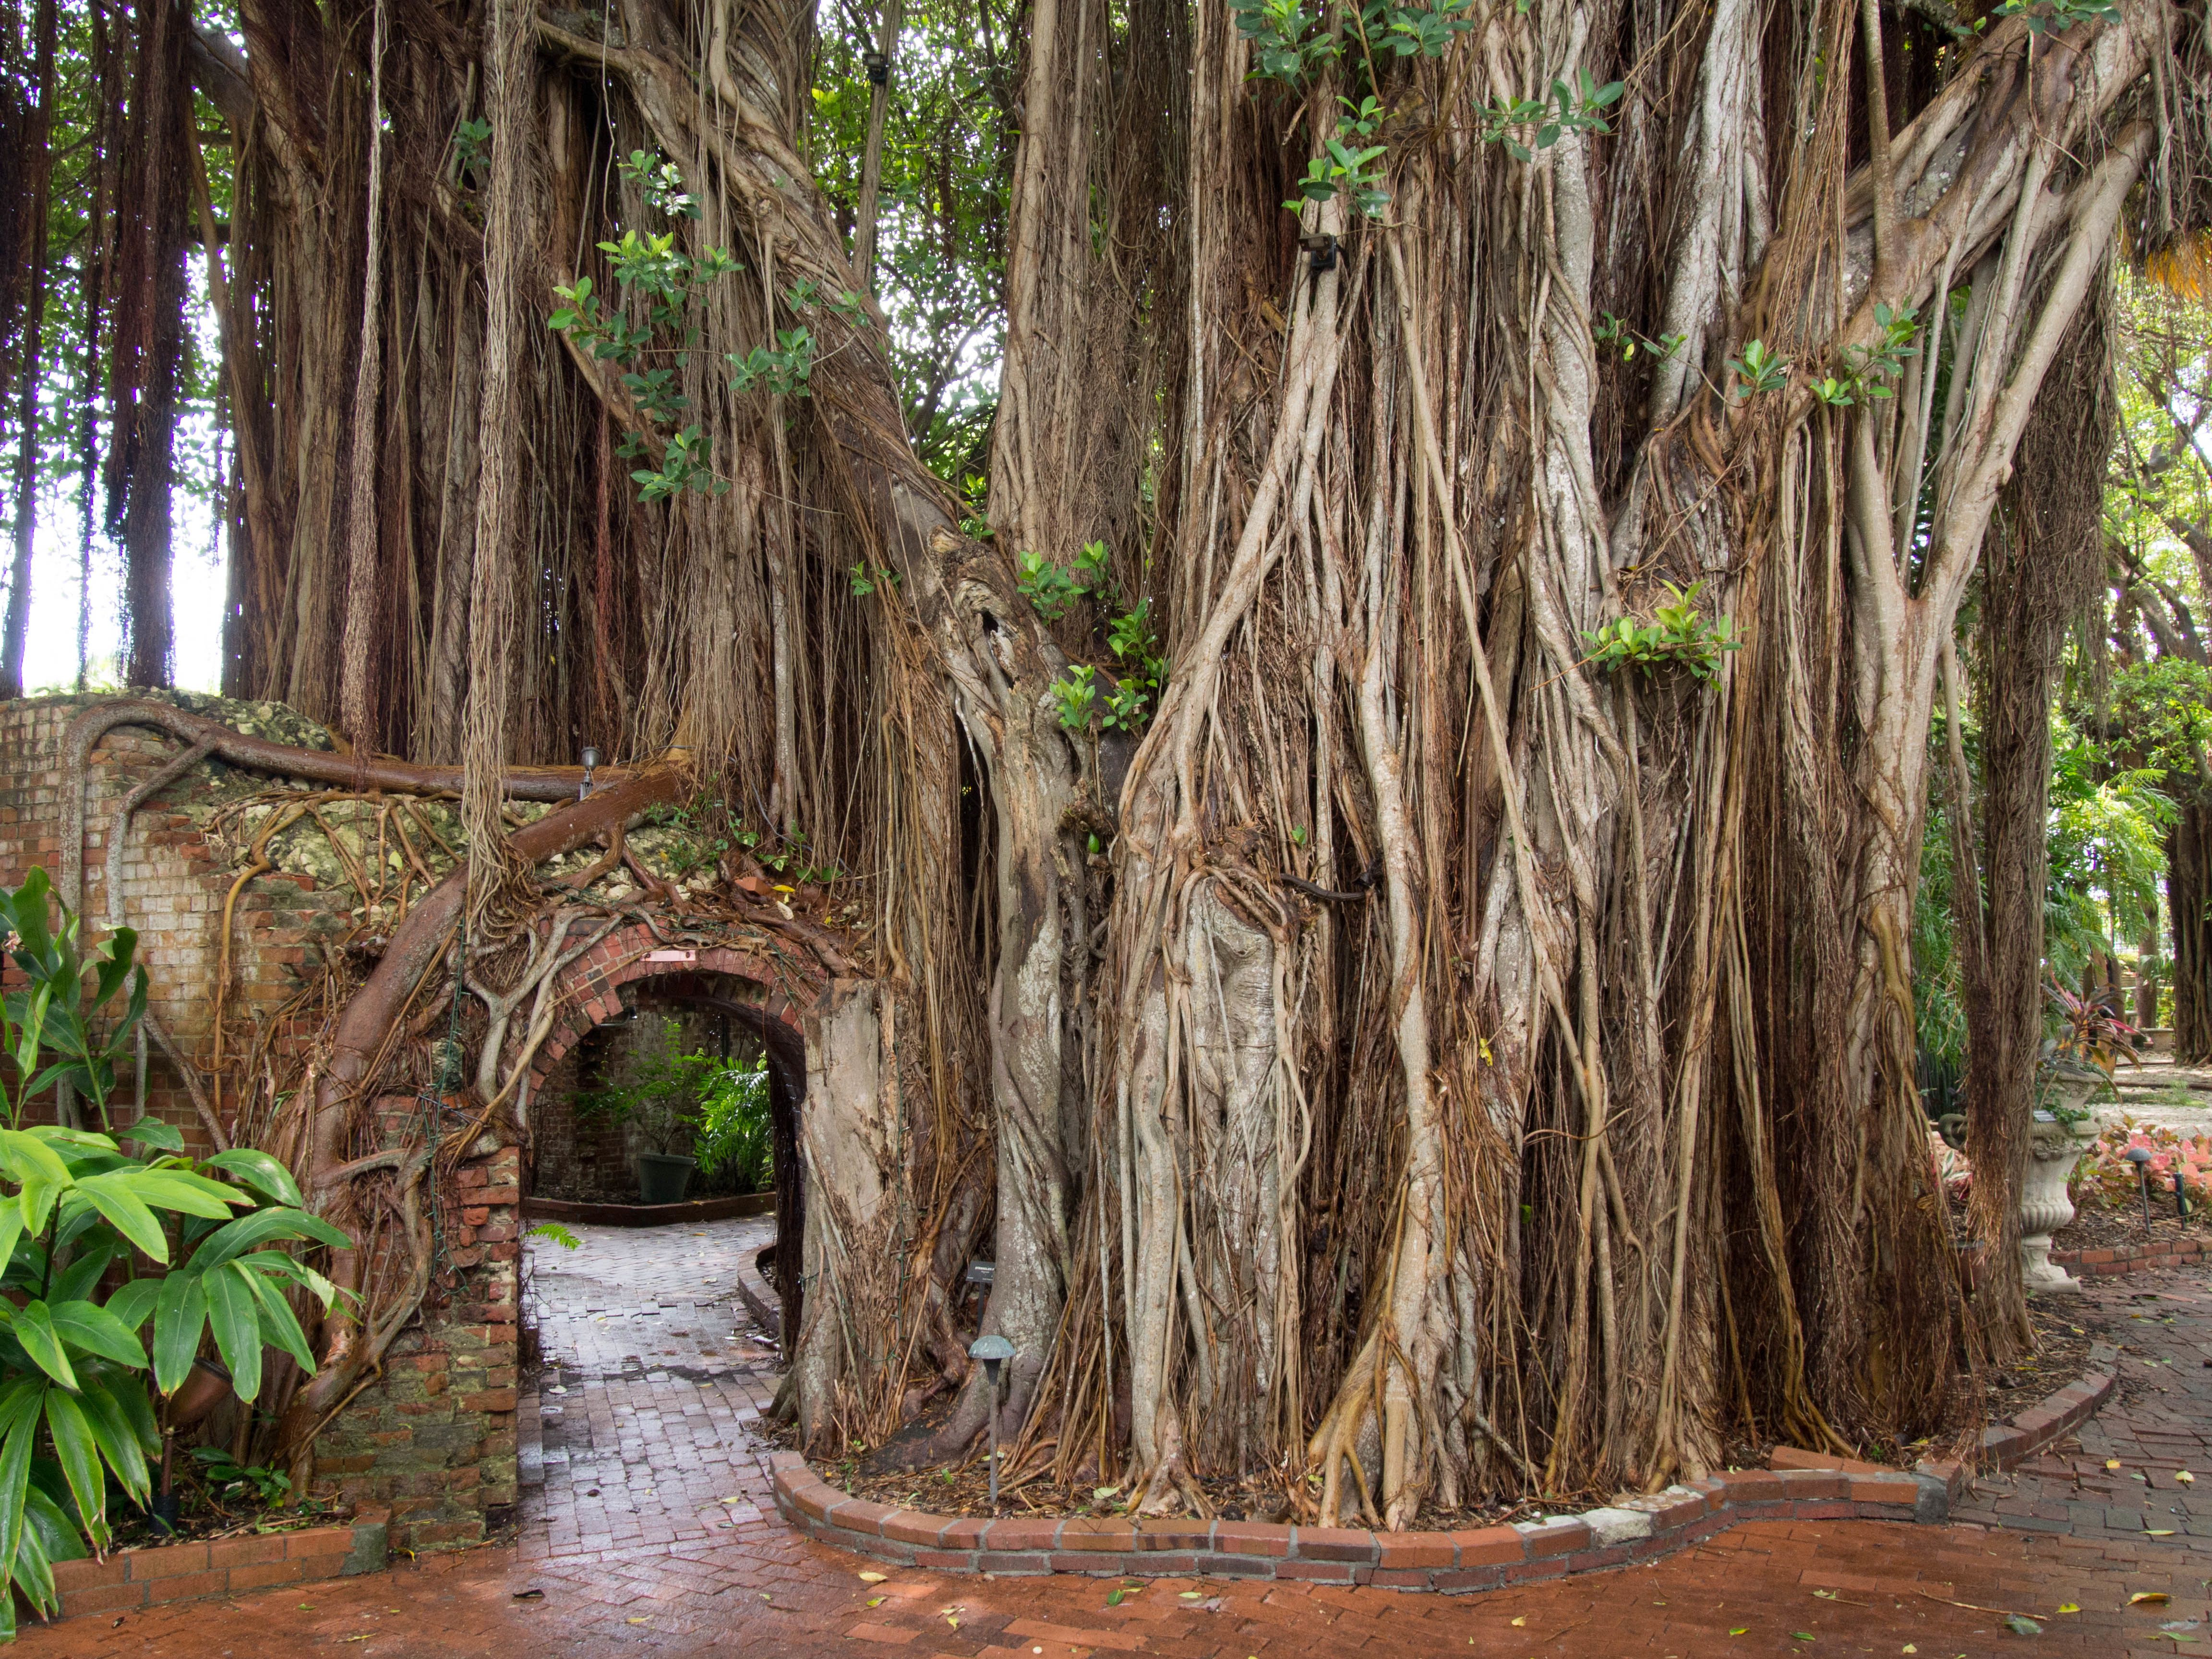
[768,1345,2117,1595]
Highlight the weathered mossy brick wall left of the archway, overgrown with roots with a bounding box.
[0,697,520,1551]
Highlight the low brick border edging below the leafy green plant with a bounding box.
[53,1504,392,1622]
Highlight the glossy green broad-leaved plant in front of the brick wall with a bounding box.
[0,869,349,1637]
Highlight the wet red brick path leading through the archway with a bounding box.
[22,1223,2212,1659]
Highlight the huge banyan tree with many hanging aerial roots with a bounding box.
[4,0,2212,1527]
